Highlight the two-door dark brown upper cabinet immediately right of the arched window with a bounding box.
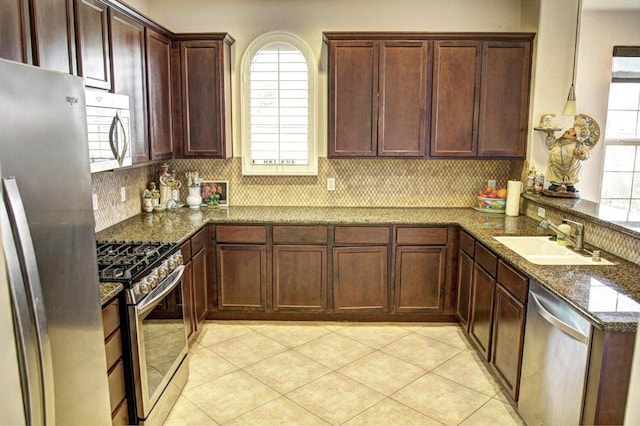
[325,34,430,157]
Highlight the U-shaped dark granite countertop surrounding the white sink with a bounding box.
[97,207,640,332]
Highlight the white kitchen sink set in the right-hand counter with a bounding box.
[493,236,613,265]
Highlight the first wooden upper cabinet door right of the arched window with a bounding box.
[329,41,378,157]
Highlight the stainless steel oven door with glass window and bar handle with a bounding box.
[129,265,188,419]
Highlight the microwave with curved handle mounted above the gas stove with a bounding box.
[85,90,131,173]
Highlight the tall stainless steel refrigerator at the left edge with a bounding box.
[0,60,111,426]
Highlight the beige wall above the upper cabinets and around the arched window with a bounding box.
[147,0,521,156]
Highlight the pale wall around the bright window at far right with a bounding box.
[576,10,640,201]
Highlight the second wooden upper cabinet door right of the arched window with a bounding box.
[380,41,431,157]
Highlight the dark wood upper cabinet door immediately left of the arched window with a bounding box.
[180,40,231,158]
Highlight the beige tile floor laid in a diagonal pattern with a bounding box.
[165,321,524,426]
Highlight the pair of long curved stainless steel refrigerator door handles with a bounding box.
[0,178,55,424]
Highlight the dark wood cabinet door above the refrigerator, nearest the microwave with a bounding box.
[31,0,77,74]
